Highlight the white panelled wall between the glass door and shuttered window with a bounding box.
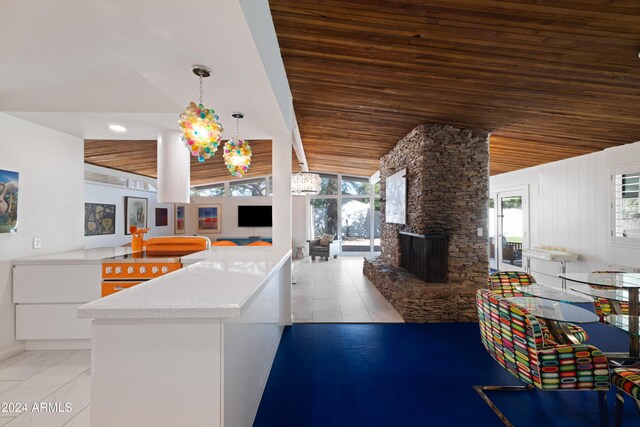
[490,142,640,284]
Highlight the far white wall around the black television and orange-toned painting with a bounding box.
[185,196,273,242]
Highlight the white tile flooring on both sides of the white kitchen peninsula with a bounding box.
[0,257,403,427]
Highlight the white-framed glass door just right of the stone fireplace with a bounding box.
[489,189,529,271]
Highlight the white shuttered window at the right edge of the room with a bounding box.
[612,172,640,242]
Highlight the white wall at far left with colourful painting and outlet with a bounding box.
[0,113,84,359]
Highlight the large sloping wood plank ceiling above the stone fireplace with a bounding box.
[270,0,640,176]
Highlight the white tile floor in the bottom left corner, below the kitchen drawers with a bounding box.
[0,350,91,427]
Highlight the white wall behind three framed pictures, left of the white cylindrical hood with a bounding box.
[83,182,175,249]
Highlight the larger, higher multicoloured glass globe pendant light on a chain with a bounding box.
[179,65,223,163]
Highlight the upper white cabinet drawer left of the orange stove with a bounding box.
[13,264,100,304]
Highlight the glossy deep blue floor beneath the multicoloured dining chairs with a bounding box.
[254,323,640,427]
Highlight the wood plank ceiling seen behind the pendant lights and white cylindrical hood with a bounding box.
[84,139,300,187]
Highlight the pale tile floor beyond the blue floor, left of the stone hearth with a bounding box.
[291,256,403,323]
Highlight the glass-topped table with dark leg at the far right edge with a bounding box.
[559,273,640,358]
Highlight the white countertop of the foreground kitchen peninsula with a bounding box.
[78,246,291,319]
